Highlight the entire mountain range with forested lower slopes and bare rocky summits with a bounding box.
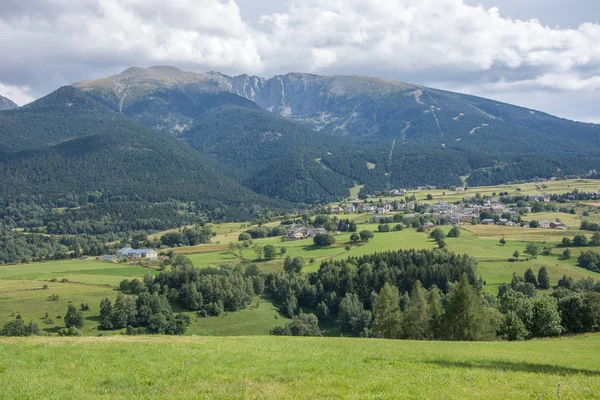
[0,67,600,227]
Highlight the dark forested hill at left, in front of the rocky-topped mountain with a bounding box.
[0,87,290,223]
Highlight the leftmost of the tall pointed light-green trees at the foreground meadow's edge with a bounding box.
[373,283,402,339]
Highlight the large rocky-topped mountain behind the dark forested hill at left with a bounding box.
[74,67,600,197]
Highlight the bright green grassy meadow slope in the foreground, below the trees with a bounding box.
[0,335,600,399]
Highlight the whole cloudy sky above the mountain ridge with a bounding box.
[0,0,600,123]
